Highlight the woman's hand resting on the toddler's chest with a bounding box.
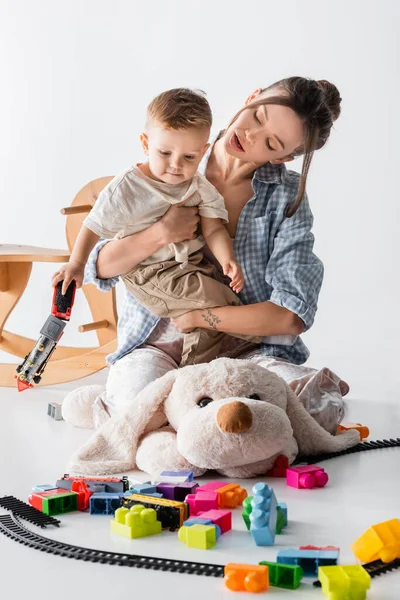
[159,200,200,244]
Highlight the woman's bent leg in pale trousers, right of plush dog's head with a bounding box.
[240,350,349,435]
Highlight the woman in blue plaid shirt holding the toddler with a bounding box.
[63,77,348,433]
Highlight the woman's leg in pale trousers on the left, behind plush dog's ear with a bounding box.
[62,346,178,429]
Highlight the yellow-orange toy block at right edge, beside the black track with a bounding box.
[351,519,400,563]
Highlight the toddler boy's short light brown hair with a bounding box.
[147,88,212,129]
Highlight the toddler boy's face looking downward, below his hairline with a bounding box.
[142,124,210,184]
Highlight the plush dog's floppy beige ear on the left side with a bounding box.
[68,370,178,475]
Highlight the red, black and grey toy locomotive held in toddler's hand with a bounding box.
[15,281,76,392]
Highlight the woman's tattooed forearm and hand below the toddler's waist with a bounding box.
[172,302,304,337]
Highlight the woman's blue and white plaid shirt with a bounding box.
[85,148,324,364]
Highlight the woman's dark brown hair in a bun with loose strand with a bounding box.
[231,77,342,217]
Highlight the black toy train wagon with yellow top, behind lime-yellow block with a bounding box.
[121,494,188,531]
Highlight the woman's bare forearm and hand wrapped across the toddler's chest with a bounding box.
[97,204,199,279]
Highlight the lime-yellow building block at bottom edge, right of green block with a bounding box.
[318,565,371,600]
